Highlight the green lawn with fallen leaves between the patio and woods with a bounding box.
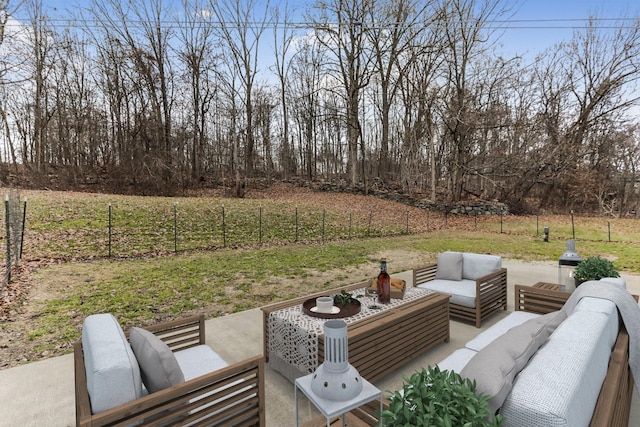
[0,185,640,366]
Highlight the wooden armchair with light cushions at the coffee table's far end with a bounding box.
[413,252,507,328]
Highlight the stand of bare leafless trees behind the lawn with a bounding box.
[0,0,640,215]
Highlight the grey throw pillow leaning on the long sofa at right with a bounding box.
[460,311,567,412]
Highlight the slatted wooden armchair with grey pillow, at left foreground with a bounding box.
[74,314,265,427]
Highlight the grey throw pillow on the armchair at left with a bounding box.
[129,327,184,393]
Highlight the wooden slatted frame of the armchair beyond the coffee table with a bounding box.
[413,263,507,328]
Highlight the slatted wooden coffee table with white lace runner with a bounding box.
[262,282,450,382]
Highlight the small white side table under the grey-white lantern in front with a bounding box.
[294,374,382,427]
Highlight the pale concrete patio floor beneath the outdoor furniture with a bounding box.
[0,259,640,427]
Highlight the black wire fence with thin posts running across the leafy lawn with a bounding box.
[5,191,640,276]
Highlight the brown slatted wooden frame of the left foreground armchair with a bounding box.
[74,315,265,427]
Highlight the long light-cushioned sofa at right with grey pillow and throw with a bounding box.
[349,280,640,427]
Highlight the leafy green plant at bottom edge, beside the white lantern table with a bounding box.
[381,366,503,427]
